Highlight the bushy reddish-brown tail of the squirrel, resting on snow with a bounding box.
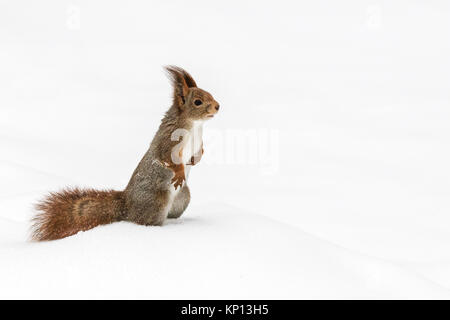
[31,188,125,241]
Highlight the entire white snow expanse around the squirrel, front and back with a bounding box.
[0,0,450,299]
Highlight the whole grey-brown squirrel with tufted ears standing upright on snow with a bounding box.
[31,66,219,241]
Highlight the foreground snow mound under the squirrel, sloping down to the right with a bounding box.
[0,203,449,299]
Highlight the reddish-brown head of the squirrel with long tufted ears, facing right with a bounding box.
[165,66,219,120]
